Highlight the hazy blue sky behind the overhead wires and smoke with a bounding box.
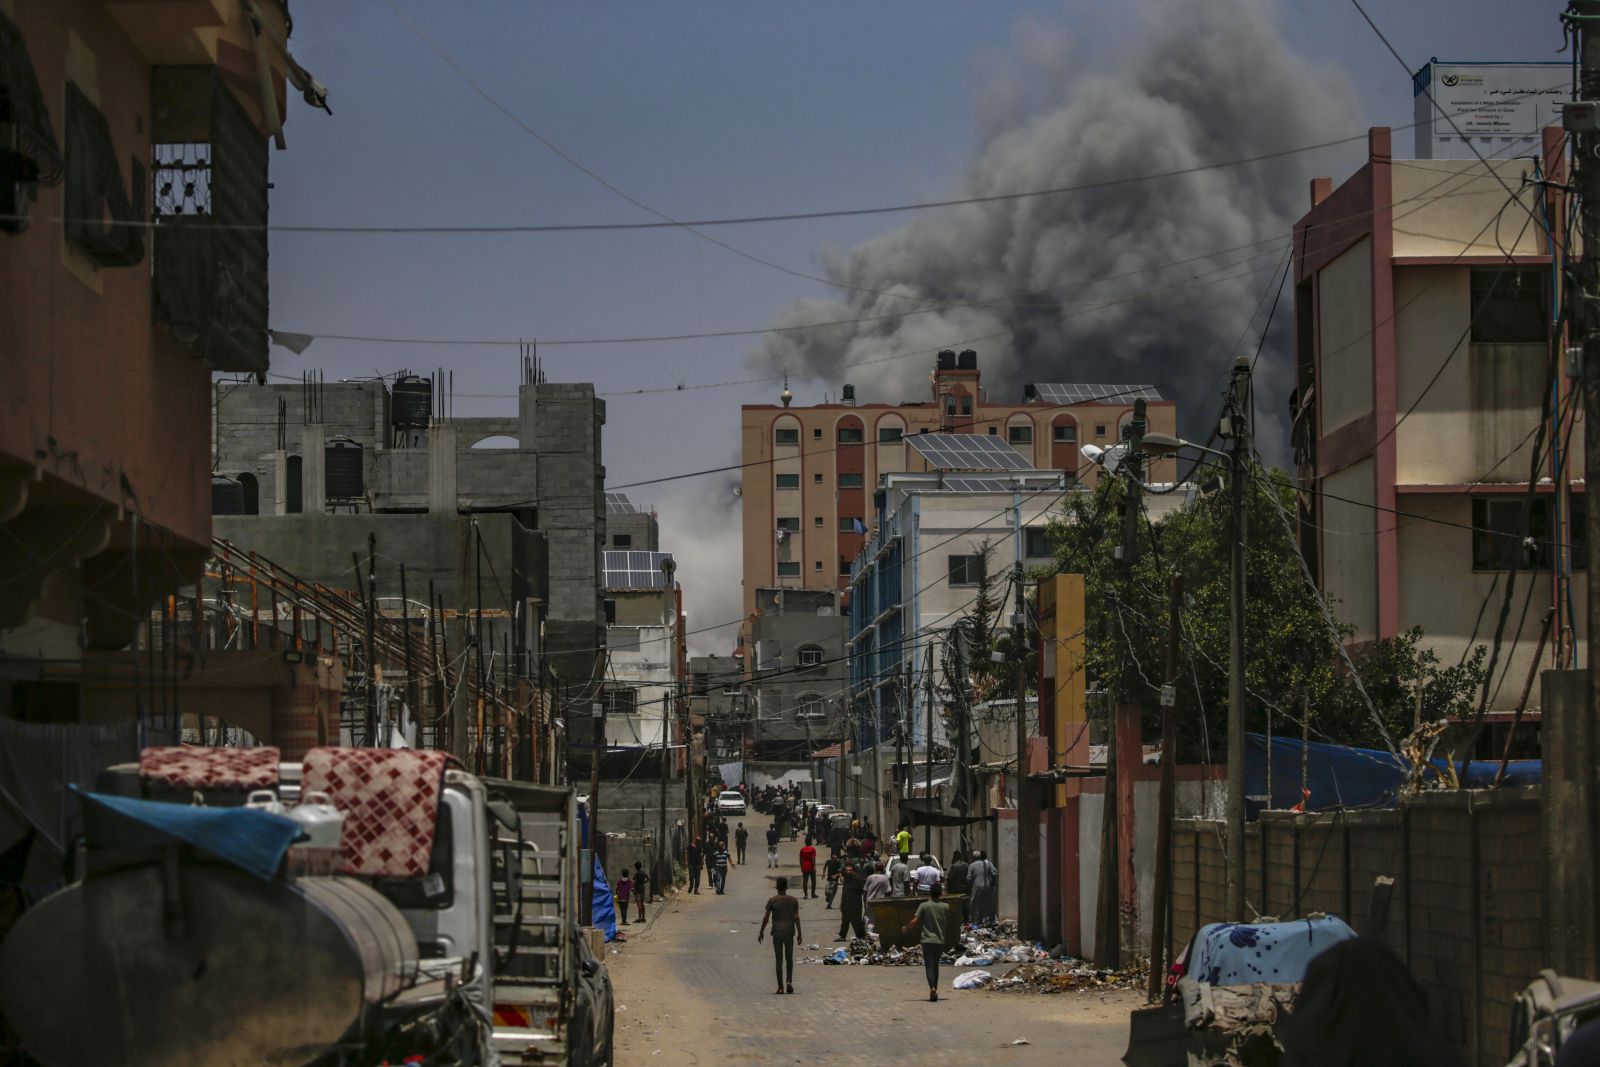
[272,0,1562,646]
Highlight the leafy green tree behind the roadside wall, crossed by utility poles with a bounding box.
[1050,469,1485,760]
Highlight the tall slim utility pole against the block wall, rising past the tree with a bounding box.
[1218,355,1248,923]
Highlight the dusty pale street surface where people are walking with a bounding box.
[606,843,1144,1067]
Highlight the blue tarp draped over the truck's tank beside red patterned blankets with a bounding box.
[72,785,304,880]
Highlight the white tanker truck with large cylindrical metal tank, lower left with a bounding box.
[0,751,613,1067]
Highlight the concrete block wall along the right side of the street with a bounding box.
[1173,787,1550,1067]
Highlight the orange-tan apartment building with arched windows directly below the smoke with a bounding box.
[741,350,1176,616]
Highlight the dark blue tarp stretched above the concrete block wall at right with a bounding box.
[1245,734,1544,811]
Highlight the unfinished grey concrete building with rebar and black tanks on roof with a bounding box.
[213,374,606,771]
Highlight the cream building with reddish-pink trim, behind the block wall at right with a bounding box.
[1293,128,1587,726]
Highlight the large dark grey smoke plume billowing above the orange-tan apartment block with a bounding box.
[750,0,1360,454]
